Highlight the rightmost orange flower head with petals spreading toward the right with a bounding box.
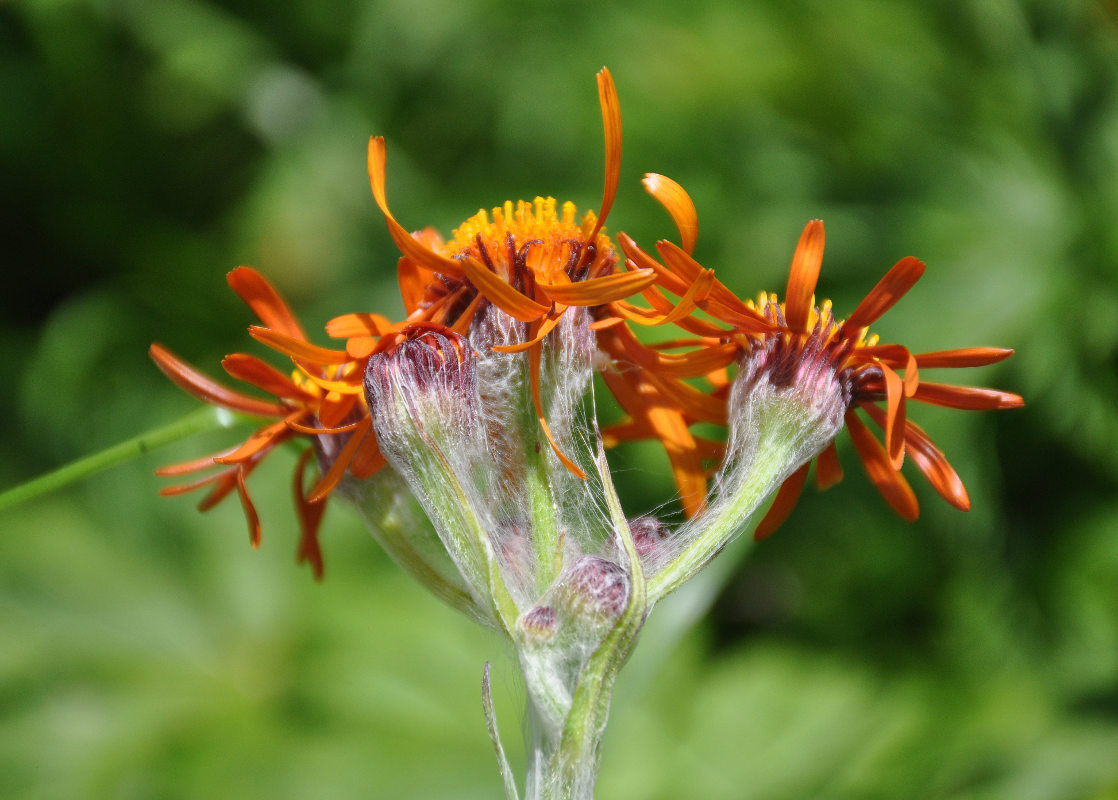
[733,220,1024,539]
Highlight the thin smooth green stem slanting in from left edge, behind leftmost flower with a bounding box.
[0,406,238,511]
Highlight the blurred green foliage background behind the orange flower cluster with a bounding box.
[0,0,1118,800]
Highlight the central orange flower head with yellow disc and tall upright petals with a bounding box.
[351,68,656,477]
